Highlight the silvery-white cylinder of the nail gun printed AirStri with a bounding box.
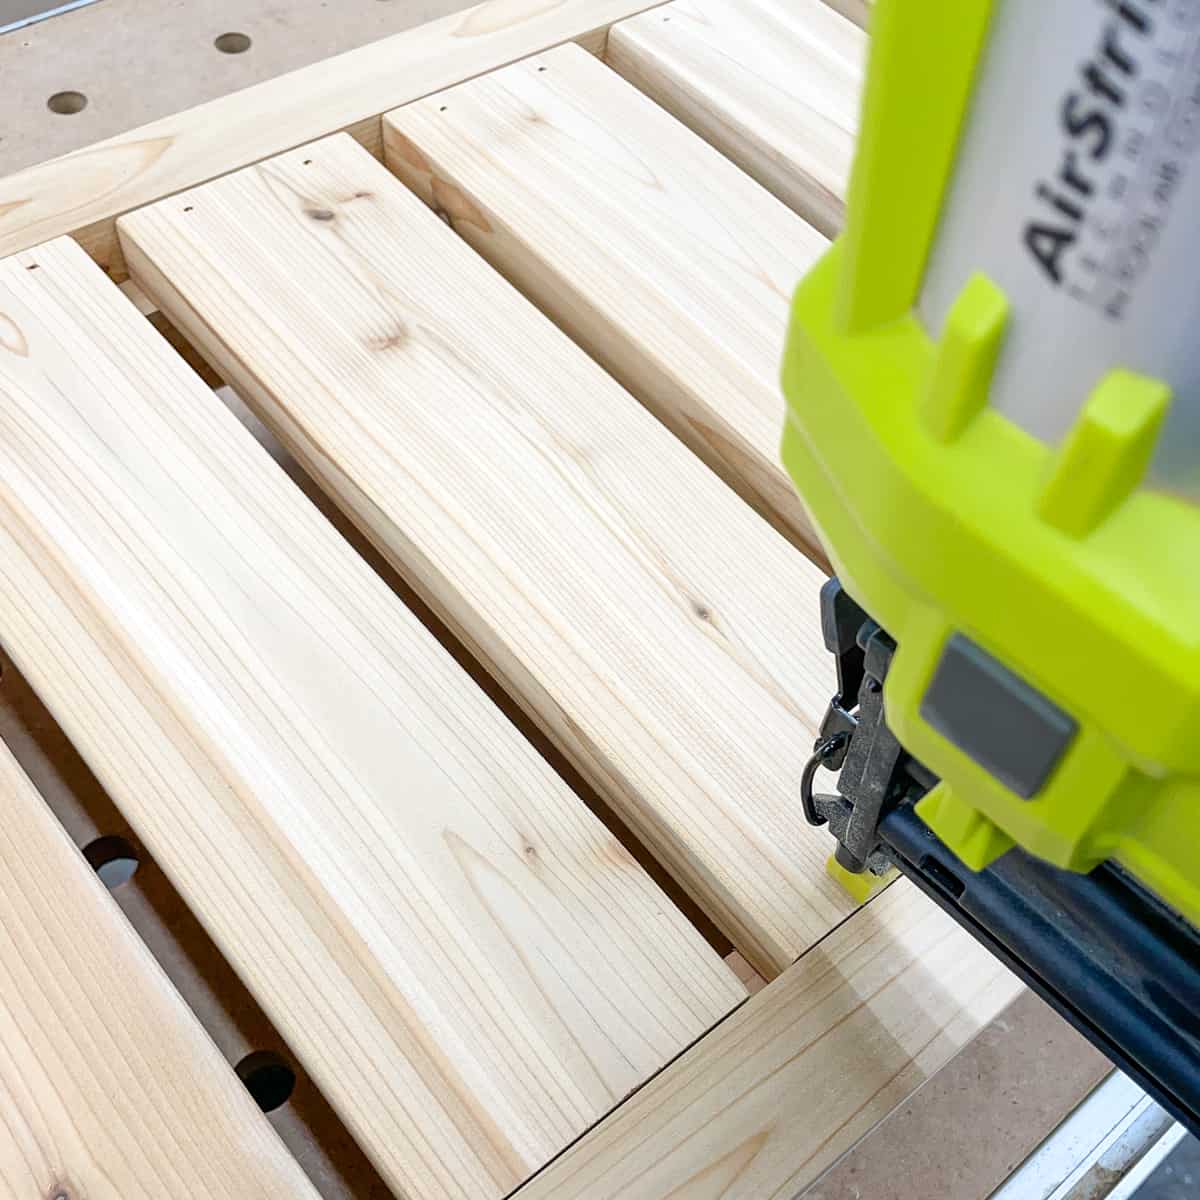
[914,0,1200,503]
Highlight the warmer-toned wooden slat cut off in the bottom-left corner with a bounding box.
[0,734,317,1200]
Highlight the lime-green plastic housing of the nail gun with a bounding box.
[782,0,1200,925]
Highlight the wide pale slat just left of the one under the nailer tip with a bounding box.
[0,234,744,1200]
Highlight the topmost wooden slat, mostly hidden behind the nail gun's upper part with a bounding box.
[606,0,866,238]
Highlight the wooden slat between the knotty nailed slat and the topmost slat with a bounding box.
[384,46,826,564]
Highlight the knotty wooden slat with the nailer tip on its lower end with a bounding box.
[121,138,864,974]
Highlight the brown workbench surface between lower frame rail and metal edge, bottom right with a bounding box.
[803,991,1112,1200]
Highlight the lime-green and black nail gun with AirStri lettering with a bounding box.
[782,0,1200,1132]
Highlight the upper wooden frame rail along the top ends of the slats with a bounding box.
[0,0,667,280]
